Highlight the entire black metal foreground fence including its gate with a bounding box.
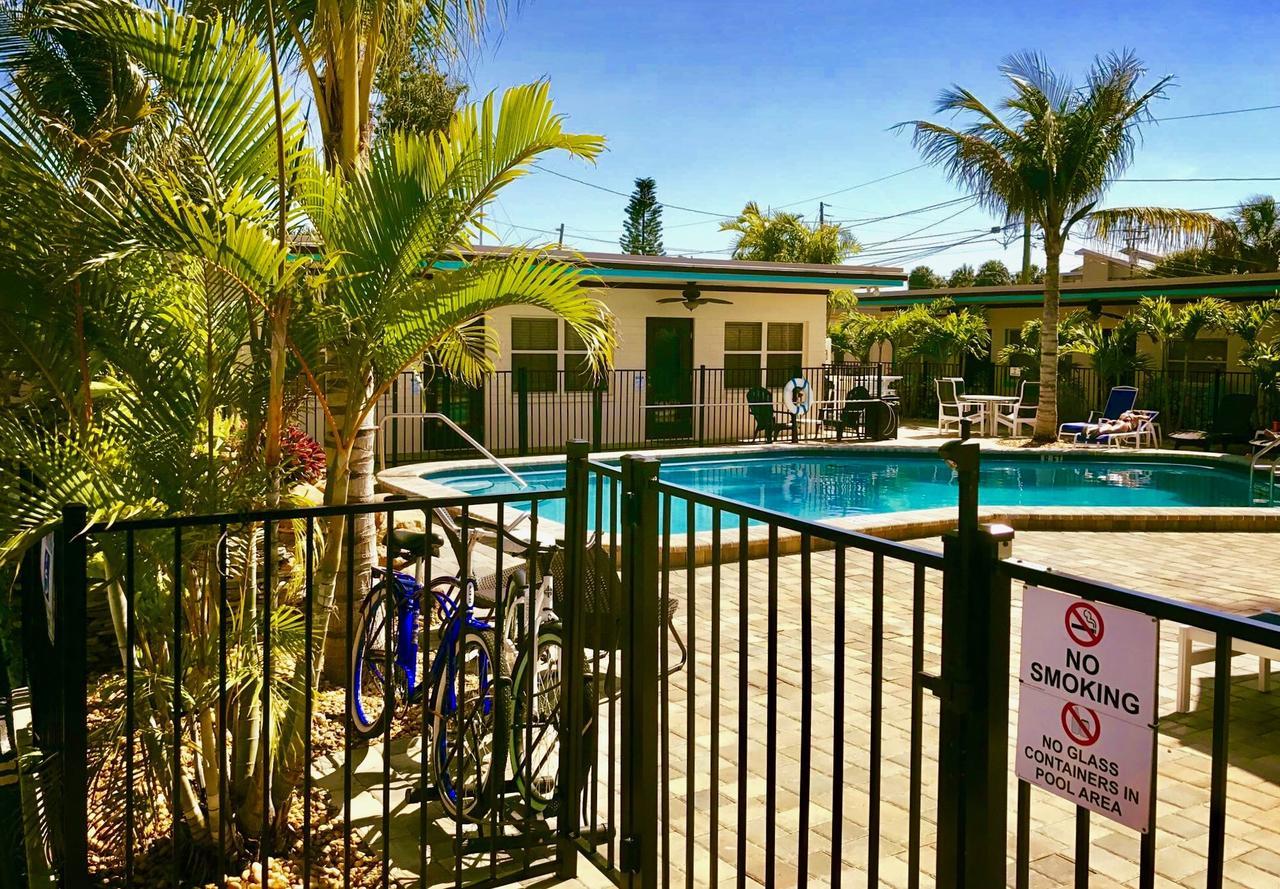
[24,441,1280,889]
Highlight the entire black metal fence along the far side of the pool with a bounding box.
[298,362,1280,466]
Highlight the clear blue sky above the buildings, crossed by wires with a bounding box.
[467,0,1280,271]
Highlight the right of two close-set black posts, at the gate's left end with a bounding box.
[618,454,659,889]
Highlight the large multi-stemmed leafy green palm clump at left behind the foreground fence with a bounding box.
[0,4,612,854]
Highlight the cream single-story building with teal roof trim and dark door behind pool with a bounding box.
[353,247,906,458]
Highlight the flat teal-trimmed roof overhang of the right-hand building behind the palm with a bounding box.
[860,272,1280,308]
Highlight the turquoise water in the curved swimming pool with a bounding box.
[422,452,1249,532]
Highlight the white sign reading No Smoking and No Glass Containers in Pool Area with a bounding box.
[1016,587,1160,833]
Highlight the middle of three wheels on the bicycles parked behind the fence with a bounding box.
[429,627,511,820]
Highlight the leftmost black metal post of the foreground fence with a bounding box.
[54,503,88,889]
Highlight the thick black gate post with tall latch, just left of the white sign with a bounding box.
[936,441,1012,889]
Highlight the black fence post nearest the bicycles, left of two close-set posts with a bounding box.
[556,439,586,880]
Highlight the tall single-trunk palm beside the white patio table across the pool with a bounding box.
[900,54,1219,441]
